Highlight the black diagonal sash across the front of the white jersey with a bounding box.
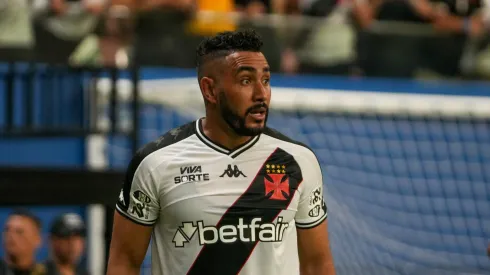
[187,148,303,275]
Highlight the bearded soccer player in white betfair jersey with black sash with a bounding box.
[108,31,335,275]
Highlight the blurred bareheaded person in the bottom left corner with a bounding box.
[0,209,46,275]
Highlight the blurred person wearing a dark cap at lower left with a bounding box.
[45,213,88,275]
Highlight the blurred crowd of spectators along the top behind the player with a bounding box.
[0,0,490,79]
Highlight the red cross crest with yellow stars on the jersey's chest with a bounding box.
[264,164,289,200]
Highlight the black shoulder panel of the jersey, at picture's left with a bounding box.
[129,121,196,171]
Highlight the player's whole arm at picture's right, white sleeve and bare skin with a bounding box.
[295,152,335,275]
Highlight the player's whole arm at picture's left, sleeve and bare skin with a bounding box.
[107,151,160,275]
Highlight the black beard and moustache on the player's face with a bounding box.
[219,91,269,136]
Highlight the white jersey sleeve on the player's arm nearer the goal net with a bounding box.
[295,153,327,229]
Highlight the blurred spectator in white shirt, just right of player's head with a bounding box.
[283,0,381,75]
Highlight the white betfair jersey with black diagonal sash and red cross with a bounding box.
[116,120,327,275]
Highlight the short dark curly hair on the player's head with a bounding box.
[196,29,264,79]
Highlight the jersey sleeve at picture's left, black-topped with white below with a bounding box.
[116,153,160,226]
